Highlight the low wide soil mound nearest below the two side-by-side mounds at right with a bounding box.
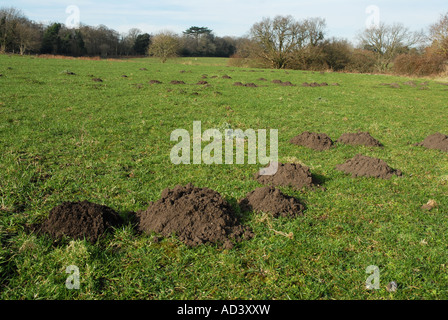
[336,154,402,179]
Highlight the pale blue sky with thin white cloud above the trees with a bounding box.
[0,0,448,41]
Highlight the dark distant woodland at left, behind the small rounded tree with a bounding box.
[0,7,236,57]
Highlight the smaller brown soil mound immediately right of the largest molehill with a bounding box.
[239,187,305,218]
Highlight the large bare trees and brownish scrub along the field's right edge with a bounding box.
[231,13,448,76]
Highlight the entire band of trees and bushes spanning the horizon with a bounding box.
[0,7,448,75]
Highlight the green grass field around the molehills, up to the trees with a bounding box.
[0,55,448,299]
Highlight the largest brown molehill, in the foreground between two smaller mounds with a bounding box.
[137,184,253,248]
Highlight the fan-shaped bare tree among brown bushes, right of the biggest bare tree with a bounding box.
[358,23,425,71]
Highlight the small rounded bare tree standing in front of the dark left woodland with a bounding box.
[148,31,180,63]
